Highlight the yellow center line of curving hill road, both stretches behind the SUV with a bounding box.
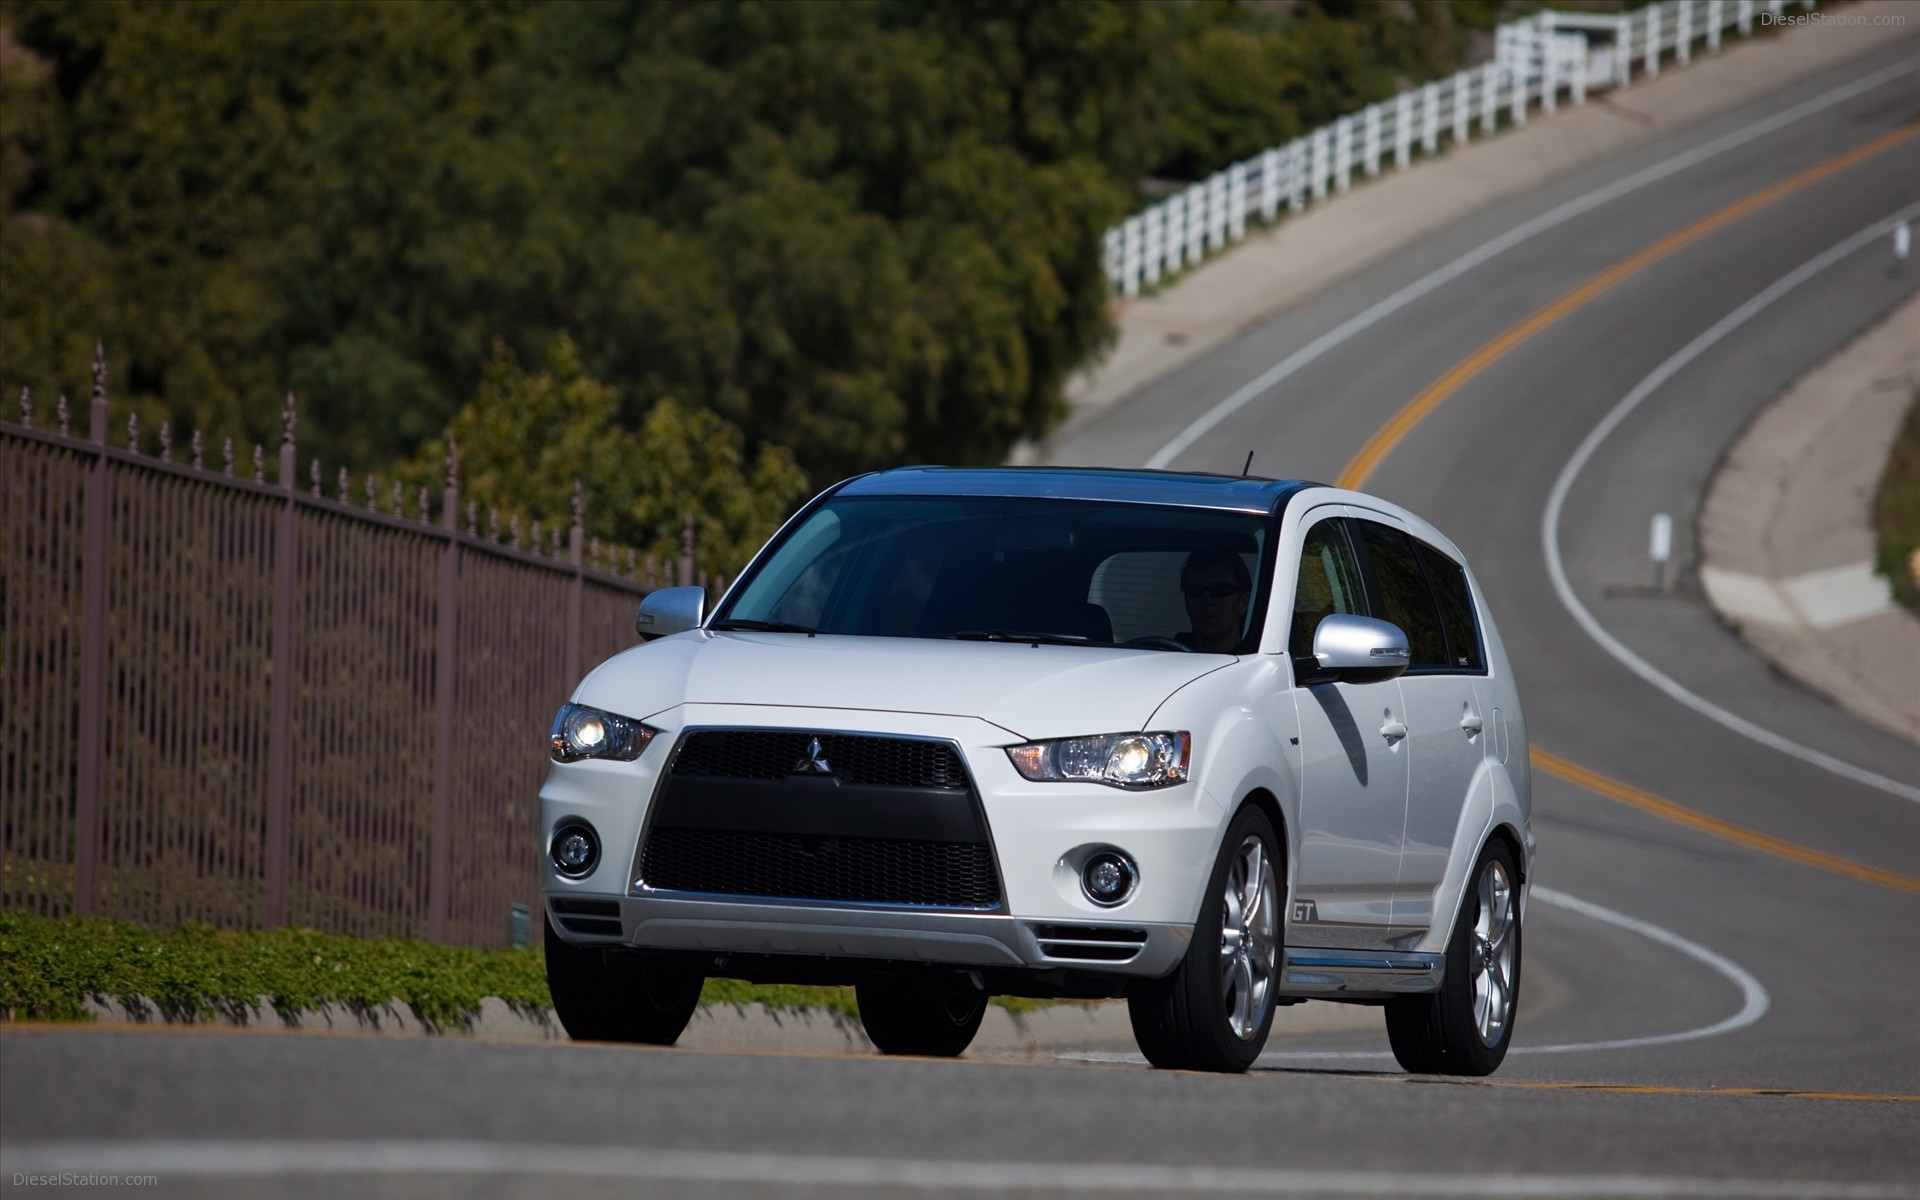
[1336,121,1920,895]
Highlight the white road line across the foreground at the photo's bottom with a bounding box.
[0,1139,1916,1200]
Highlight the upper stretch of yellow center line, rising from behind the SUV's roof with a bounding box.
[1336,121,1920,490]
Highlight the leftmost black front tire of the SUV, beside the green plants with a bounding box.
[547,918,707,1046]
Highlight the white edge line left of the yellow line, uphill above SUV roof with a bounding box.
[1146,60,1920,468]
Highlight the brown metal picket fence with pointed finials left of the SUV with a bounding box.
[0,351,691,945]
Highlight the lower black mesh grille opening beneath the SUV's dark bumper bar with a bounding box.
[639,828,1000,908]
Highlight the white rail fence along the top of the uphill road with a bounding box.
[1102,0,1814,296]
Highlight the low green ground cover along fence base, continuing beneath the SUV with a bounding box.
[0,912,1050,1029]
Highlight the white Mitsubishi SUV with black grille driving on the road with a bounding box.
[540,467,1534,1075]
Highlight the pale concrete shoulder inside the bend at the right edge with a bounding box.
[1699,296,1920,743]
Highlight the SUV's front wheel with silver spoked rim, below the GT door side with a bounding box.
[1127,806,1286,1071]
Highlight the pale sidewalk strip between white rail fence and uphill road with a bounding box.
[1052,0,1920,449]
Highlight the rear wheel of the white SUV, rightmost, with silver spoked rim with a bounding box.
[1386,841,1521,1075]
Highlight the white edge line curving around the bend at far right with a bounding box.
[1540,204,1920,803]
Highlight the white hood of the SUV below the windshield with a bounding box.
[574,630,1236,739]
